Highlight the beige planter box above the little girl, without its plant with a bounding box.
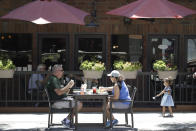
[158,71,178,79]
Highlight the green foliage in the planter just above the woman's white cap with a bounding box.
[113,60,142,71]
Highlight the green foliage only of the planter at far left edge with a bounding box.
[0,59,15,70]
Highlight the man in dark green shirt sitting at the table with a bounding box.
[46,65,82,128]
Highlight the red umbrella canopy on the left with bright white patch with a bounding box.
[1,0,89,25]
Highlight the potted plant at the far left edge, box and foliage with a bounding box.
[0,59,15,78]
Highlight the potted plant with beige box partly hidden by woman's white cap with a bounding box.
[113,60,142,79]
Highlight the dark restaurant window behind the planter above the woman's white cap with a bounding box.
[111,35,142,68]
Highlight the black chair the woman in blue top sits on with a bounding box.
[110,85,137,128]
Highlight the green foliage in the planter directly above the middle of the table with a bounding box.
[80,60,105,71]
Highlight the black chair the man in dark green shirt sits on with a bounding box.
[44,87,73,128]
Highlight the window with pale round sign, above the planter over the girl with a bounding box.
[148,36,178,70]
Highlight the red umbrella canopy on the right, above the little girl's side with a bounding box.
[106,0,196,18]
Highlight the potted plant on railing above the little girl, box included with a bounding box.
[153,60,178,79]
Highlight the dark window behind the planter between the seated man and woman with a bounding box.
[75,35,105,70]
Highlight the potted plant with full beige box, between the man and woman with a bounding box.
[80,60,105,79]
